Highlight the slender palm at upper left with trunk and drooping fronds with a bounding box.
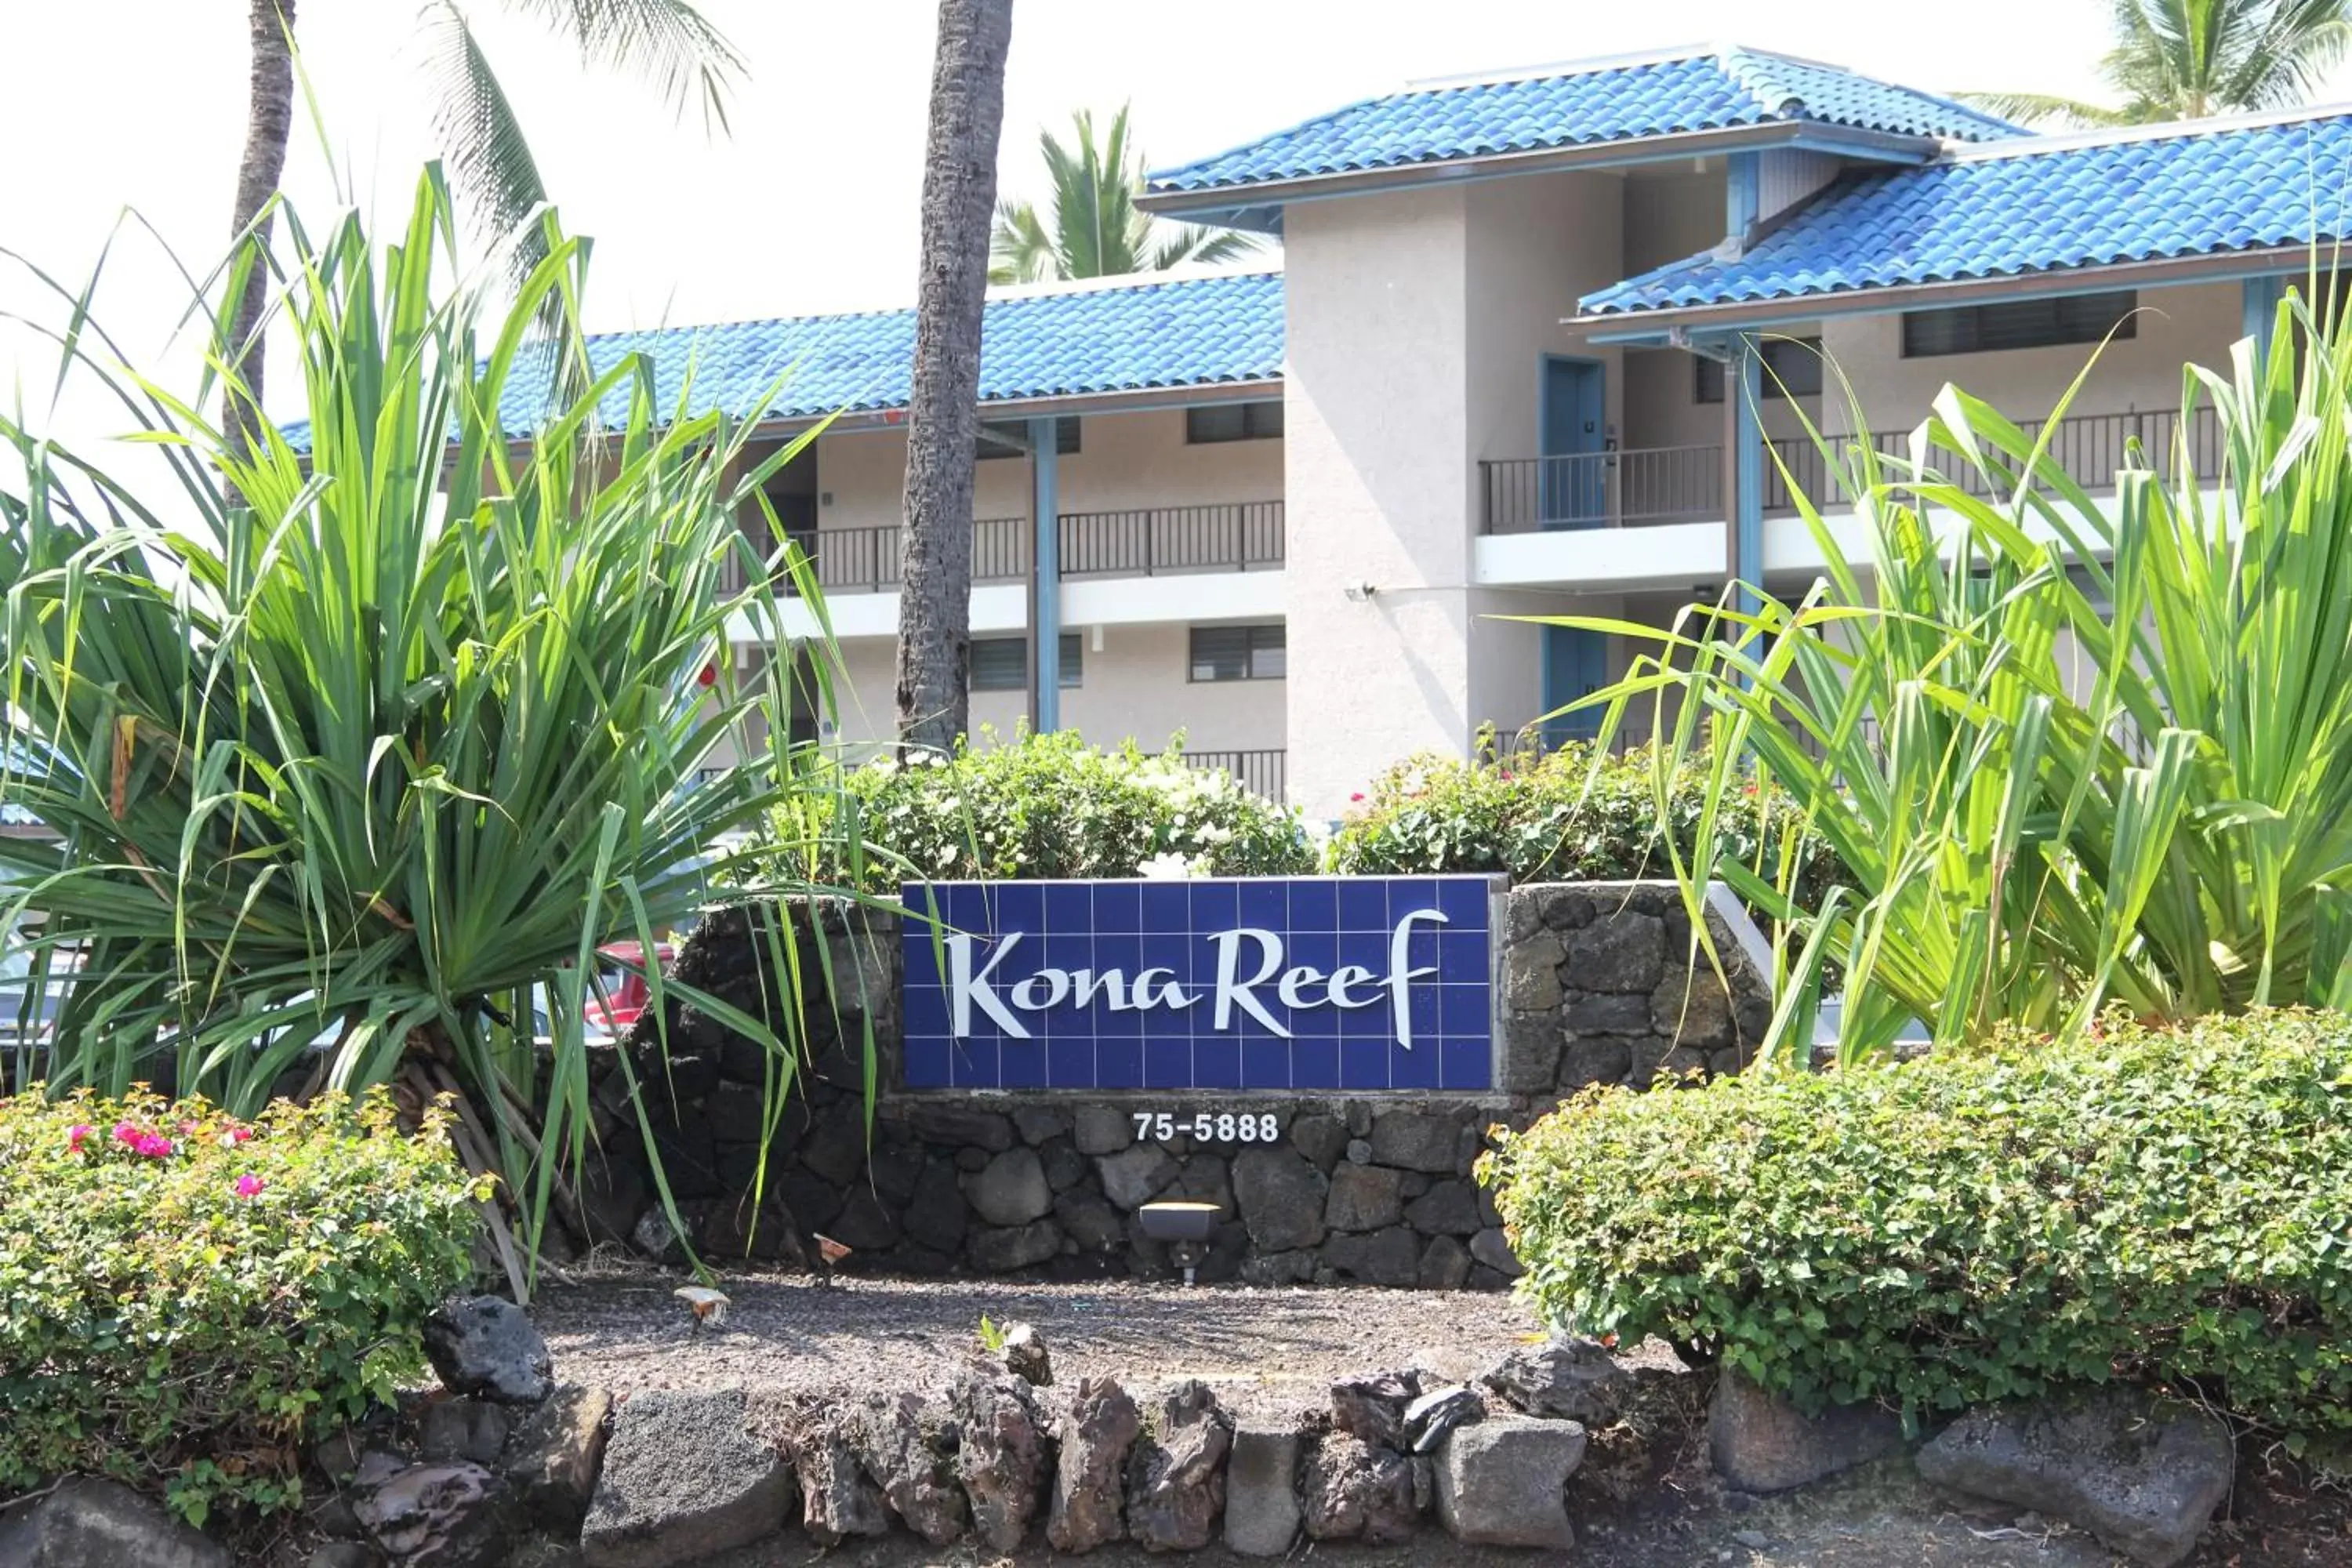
[221,0,743,454]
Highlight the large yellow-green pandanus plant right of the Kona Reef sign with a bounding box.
[1566,292,2352,1060]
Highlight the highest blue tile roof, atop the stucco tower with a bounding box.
[1150,47,2023,193]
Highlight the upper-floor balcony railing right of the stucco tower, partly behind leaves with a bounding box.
[1479,407,2223,534]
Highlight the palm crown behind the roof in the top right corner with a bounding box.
[1959,0,2352,125]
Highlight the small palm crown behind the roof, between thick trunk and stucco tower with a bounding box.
[988,103,1258,282]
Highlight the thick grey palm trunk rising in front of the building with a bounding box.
[898,0,1014,748]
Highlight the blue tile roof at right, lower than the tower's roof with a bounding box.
[1583,115,2352,318]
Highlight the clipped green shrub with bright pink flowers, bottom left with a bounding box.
[0,1093,487,1523]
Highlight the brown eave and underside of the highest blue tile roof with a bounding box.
[1136,120,1943,233]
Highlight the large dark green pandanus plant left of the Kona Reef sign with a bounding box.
[0,167,866,1290]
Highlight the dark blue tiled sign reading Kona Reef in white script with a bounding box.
[903,877,1494,1093]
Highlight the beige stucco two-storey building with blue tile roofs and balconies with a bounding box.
[668,49,2352,813]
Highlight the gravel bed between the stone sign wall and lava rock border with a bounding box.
[532,1274,1536,1413]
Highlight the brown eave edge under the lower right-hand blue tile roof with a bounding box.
[1562,240,2333,348]
